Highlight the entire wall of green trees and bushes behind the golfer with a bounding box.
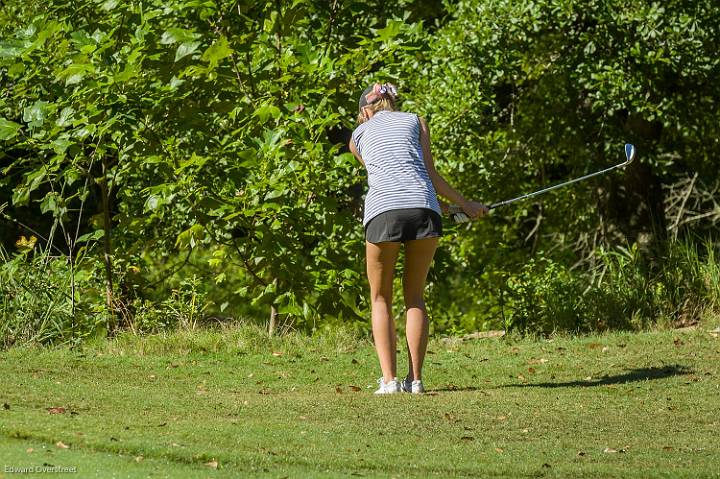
[0,0,720,342]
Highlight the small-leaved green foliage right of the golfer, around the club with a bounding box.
[405,0,720,330]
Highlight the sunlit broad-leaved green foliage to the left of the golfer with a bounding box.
[0,0,428,336]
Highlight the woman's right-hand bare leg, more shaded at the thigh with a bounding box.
[403,238,439,380]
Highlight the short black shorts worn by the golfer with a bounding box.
[365,208,442,243]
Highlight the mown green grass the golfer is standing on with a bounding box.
[0,326,720,478]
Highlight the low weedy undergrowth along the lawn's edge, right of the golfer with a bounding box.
[498,241,720,333]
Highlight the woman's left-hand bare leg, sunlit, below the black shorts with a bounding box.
[365,242,400,383]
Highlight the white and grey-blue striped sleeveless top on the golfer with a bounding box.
[352,111,441,226]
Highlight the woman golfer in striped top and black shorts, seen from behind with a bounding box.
[350,83,488,394]
